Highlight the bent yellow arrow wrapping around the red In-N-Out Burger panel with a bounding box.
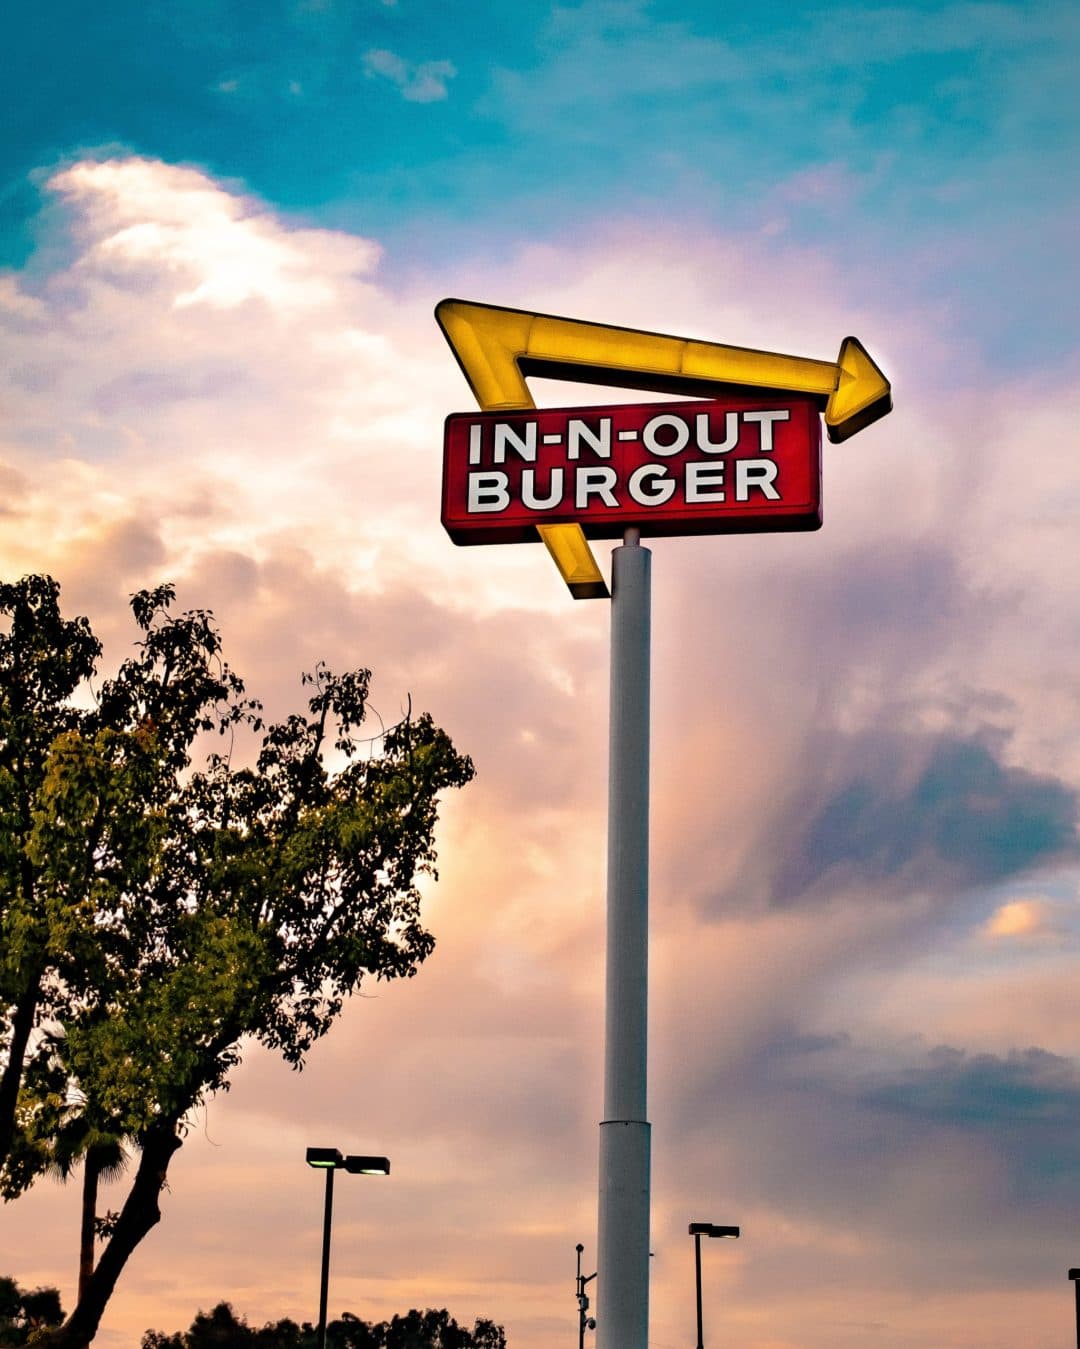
[436,299,893,599]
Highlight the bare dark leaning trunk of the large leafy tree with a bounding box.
[40,1120,182,1349]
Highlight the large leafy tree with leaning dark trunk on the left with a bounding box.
[0,576,473,1349]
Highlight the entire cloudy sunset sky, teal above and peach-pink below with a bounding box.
[0,0,1080,1349]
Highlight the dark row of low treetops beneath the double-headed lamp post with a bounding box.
[139,1302,506,1349]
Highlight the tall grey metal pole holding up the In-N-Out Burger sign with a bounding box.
[596,529,653,1349]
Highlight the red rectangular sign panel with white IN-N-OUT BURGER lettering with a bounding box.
[442,394,821,544]
